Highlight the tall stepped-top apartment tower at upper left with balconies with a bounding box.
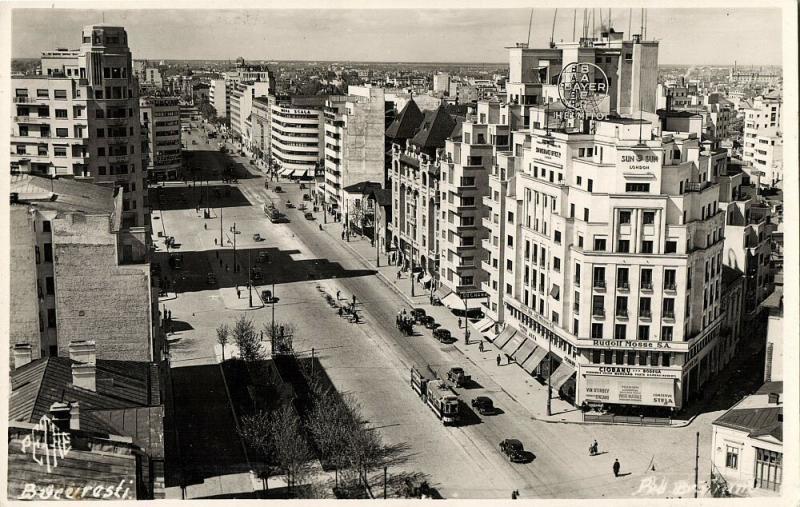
[11,25,148,227]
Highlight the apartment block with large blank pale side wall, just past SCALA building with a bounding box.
[323,86,386,210]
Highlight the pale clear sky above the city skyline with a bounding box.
[11,8,782,65]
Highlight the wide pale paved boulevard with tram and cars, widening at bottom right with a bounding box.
[153,126,720,498]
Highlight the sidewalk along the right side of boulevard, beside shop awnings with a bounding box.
[323,222,583,423]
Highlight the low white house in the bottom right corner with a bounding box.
[711,382,783,497]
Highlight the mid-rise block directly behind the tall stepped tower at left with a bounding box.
[139,97,183,181]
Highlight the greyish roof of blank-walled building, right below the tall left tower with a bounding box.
[9,174,116,214]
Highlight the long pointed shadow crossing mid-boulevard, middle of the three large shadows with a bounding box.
[152,248,376,293]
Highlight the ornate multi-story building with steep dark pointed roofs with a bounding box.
[389,103,460,285]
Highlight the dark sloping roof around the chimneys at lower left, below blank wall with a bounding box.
[9,357,159,433]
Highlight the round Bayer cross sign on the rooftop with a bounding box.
[558,63,608,119]
